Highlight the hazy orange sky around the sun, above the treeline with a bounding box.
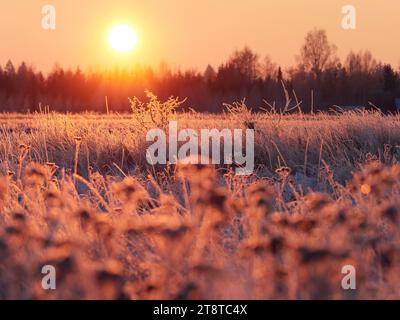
[0,0,400,72]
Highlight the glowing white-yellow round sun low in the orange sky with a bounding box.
[108,24,138,52]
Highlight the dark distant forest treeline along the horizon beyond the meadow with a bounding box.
[0,29,400,112]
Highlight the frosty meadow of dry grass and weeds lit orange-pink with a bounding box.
[0,103,400,299]
